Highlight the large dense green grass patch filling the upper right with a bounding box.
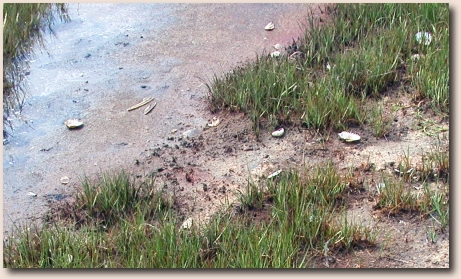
[208,3,449,137]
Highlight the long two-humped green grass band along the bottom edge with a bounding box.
[3,164,376,268]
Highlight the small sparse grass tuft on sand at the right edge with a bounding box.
[375,140,449,232]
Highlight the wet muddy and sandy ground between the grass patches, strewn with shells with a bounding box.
[3,3,449,268]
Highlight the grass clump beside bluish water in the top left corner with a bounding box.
[3,3,69,137]
